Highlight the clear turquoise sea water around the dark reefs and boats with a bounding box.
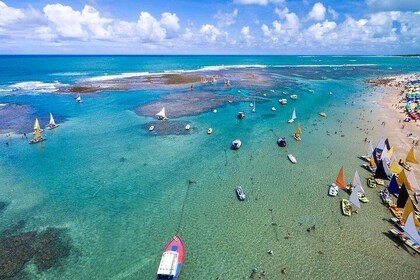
[0,56,420,279]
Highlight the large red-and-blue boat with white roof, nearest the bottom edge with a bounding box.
[156,235,185,280]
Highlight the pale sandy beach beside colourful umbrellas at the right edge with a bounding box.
[371,74,420,180]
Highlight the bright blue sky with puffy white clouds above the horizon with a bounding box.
[0,0,420,55]
